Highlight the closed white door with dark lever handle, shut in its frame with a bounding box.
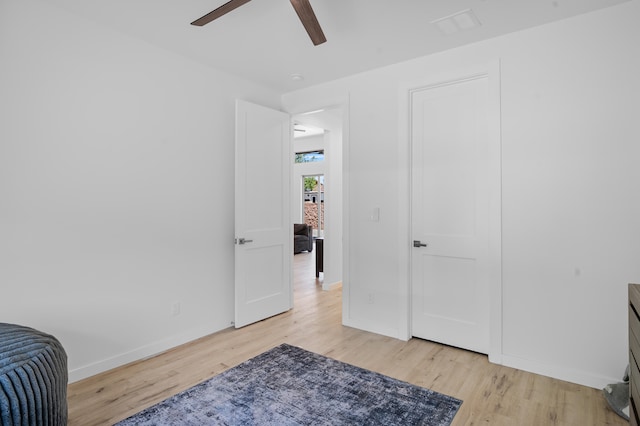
[411,77,490,353]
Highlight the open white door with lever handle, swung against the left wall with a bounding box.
[235,100,293,328]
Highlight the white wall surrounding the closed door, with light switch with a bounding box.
[283,0,640,387]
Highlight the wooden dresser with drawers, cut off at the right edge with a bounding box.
[629,284,640,426]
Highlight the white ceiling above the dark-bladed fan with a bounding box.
[46,0,628,92]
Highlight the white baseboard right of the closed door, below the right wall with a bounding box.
[502,354,623,389]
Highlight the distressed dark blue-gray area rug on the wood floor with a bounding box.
[117,344,462,426]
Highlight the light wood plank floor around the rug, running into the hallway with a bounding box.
[68,253,628,426]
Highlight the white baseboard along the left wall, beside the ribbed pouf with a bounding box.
[69,327,220,383]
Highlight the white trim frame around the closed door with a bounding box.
[397,59,503,364]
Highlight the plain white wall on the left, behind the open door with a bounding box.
[0,0,280,381]
